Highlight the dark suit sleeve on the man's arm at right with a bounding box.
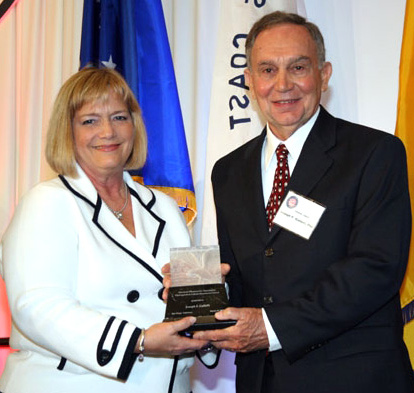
[266,136,411,361]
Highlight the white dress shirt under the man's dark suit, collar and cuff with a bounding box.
[262,108,320,351]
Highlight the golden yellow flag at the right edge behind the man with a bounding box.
[395,1,414,365]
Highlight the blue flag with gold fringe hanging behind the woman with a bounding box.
[80,0,196,223]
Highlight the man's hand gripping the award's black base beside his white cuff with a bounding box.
[193,307,269,352]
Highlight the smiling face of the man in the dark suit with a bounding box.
[245,24,332,140]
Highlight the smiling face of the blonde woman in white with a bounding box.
[72,93,135,177]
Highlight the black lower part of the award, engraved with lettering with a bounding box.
[164,284,236,333]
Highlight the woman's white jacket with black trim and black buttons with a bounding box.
[0,169,210,393]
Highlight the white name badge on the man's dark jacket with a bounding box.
[273,191,326,240]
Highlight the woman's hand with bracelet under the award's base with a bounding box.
[135,317,208,355]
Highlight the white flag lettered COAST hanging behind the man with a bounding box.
[201,0,298,245]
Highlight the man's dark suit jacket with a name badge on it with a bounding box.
[212,107,414,393]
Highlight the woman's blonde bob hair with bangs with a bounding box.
[45,68,147,177]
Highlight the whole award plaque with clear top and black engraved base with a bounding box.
[164,246,236,332]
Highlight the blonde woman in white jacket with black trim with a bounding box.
[0,68,215,393]
